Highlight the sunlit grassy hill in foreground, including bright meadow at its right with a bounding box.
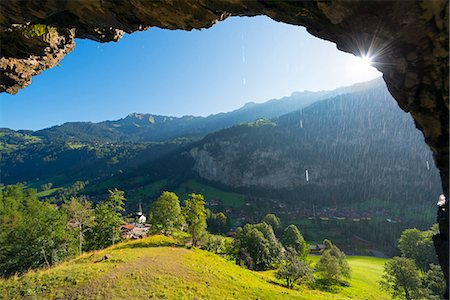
[0,236,388,299]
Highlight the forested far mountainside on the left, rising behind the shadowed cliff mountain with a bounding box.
[0,79,380,186]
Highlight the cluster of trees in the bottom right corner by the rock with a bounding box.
[380,225,446,300]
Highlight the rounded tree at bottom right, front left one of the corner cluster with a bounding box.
[380,257,424,300]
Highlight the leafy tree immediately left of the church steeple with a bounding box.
[86,189,126,250]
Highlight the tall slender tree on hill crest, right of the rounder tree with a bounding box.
[182,193,206,247]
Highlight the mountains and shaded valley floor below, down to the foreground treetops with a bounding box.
[0,79,441,253]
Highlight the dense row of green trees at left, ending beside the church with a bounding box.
[0,185,126,276]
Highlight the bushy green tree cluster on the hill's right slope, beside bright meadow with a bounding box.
[233,214,350,288]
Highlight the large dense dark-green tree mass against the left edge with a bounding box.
[0,185,75,276]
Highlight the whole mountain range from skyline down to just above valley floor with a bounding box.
[0,79,439,209]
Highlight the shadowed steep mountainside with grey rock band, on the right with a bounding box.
[188,86,439,201]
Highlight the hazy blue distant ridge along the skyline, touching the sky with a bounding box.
[33,78,382,142]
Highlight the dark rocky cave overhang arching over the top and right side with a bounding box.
[0,0,449,195]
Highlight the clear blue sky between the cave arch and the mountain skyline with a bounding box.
[0,17,381,130]
